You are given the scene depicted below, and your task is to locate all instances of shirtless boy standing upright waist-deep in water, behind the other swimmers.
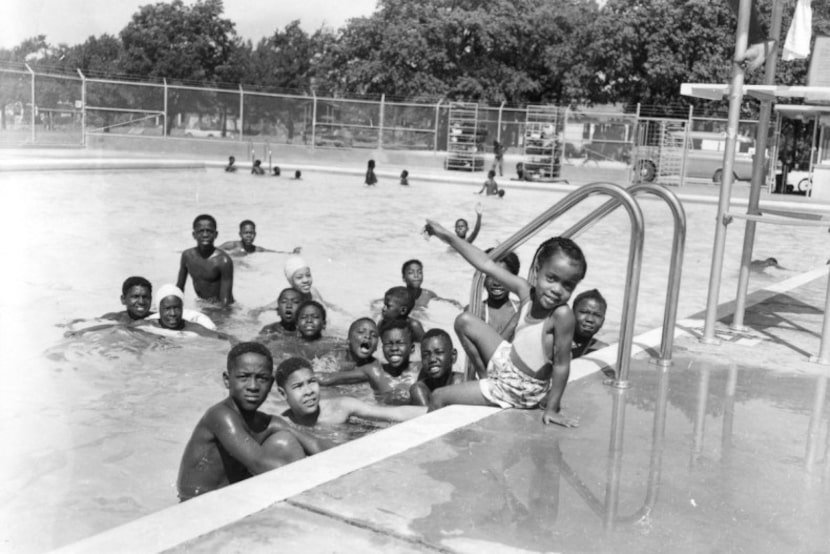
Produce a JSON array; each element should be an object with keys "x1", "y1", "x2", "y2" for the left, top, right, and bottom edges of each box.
[{"x1": 176, "y1": 214, "x2": 233, "y2": 306}]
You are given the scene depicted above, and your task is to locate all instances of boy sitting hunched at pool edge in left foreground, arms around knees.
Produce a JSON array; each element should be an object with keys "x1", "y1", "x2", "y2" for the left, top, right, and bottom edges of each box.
[{"x1": 176, "y1": 342, "x2": 332, "y2": 501}]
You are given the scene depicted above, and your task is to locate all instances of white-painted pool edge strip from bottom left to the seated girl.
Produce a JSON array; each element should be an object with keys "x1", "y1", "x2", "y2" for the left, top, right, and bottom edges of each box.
[{"x1": 54, "y1": 406, "x2": 500, "y2": 553}]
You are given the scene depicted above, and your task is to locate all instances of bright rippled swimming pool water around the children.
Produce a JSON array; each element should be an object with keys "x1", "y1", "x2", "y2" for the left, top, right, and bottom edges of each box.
[{"x1": 0, "y1": 166, "x2": 828, "y2": 551}]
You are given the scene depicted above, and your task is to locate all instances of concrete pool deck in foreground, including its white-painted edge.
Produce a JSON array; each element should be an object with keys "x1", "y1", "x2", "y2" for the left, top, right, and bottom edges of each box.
[{"x1": 50, "y1": 268, "x2": 830, "y2": 553}]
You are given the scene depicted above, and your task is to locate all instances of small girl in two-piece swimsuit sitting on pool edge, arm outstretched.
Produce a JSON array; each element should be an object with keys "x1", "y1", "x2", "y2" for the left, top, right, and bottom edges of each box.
[{"x1": 426, "y1": 220, "x2": 587, "y2": 427}]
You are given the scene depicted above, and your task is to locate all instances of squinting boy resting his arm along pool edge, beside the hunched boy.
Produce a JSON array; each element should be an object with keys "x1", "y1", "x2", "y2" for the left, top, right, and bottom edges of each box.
[{"x1": 277, "y1": 358, "x2": 426, "y2": 427}]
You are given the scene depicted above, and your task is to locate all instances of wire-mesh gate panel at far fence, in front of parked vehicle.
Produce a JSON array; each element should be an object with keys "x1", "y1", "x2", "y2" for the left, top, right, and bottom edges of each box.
[{"x1": 633, "y1": 117, "x2": 689, "y2": 186}]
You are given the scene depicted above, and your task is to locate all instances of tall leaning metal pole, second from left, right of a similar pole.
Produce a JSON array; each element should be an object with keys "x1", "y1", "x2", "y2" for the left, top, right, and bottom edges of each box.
[{"x1": 731, "y1": 0, "x2": 784, "y2": 329}]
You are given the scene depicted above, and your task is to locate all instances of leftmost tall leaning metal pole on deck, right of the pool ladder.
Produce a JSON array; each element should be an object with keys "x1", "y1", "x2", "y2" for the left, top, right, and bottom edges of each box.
[{"x1": 701, "y1": 0, "x2": 750, "y2": 344}]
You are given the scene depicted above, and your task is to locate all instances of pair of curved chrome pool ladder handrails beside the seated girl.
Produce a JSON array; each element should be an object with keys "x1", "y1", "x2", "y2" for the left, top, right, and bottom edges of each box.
[{"x1": 467, "y1": 182, "x2": 686, "y2": 389}]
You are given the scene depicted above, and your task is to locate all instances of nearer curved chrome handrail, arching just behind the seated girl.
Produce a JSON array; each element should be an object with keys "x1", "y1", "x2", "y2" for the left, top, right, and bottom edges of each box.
[{"x1": 467, "y1": 183, "x2": 644, "y2": 388}]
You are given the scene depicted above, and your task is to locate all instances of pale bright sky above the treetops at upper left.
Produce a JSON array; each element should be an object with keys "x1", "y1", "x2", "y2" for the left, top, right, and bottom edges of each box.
[{"x1": 0, "y1": 0, "x2": 377, "y2": 48}]
